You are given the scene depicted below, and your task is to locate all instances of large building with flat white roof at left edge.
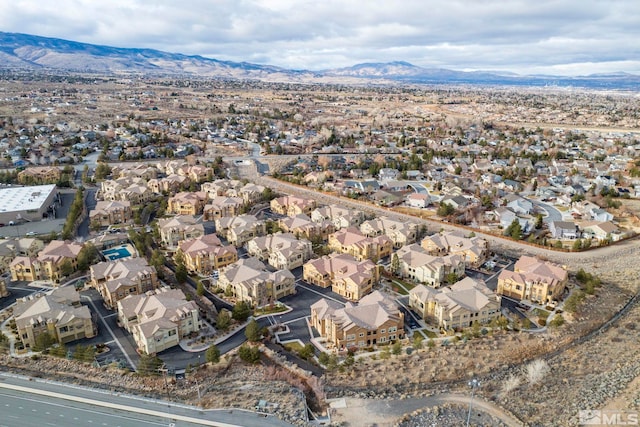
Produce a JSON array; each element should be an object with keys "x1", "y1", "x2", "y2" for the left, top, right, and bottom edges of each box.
[{"x1": 0, "y1": 184, "x2": 58, "y2": 224}]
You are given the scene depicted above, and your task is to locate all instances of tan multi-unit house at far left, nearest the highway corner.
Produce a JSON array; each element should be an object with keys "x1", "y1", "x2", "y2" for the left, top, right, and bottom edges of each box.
[{"x1": 13, "y1": 286, "x2": 97, "y2": 348}]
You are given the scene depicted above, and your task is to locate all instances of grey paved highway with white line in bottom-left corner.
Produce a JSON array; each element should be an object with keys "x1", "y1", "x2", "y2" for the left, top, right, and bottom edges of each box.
[{"x1": 0, "y1": 375, "x2": 290, "y2": 427}]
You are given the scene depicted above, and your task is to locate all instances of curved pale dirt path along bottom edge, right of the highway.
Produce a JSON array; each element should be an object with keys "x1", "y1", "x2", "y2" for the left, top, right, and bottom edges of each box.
[{"x1": 331, "y1": 394, "x2": 523, "y2": 427}]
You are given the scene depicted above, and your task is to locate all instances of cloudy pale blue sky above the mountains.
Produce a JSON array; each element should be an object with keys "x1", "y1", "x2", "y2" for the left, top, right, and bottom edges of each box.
[{"x1": 0, "y1": 0, "x2": 640, "y2": 75}]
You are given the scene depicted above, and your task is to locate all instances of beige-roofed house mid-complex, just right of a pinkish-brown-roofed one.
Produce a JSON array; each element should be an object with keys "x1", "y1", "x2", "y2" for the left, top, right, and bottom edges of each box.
[{"x1": 247, "y1": 233, "x2": 313, "y2": 270}]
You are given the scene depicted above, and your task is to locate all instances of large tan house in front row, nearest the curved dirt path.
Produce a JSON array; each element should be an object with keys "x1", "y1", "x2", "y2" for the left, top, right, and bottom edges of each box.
[{"x1": 311, "y1": 291, "x2": 404, "y2": 350}]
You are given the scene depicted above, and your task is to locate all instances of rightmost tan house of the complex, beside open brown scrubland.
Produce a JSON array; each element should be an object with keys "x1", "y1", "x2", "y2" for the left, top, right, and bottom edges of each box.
[{"x1": 497, "y1": 256, "x2": 569, "y2": 304}]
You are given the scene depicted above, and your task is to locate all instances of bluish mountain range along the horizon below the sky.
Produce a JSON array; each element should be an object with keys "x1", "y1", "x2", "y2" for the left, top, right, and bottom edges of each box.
[{"x1": 0, "y1": 32, "x2": 640, "y2": 90}]
